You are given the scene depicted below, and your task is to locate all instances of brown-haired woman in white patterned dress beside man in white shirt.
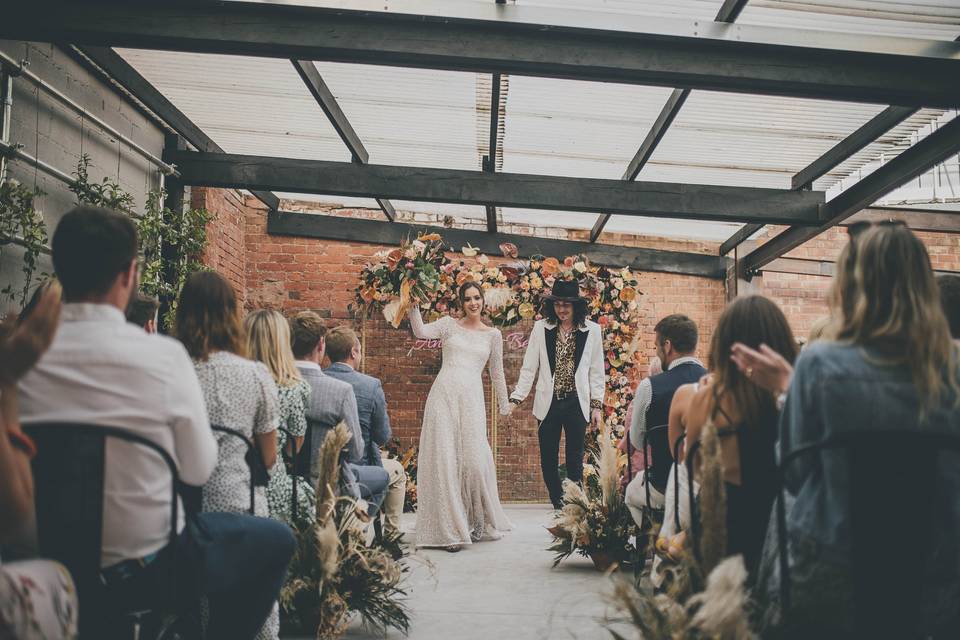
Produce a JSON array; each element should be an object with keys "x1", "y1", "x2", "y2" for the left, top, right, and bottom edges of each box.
[{"x1": 175, "y1": 271, "x2": 280, "y2": 639}]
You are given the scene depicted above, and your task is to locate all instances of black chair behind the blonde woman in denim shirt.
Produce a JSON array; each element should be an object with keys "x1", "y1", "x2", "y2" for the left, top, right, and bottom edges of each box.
[{"x1": 776, "y1": 430, "x2": 960, "y2": 638}]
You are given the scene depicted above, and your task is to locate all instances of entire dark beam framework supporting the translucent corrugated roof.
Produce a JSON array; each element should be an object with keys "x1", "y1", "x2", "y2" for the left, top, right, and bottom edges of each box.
[{"x1": 0, "y1": 0, "x2": 960, "y2": 275}]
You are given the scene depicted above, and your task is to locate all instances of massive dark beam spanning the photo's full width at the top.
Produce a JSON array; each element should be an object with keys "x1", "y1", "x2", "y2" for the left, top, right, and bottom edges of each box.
[{"x1": 7, "y1": 0, "x2": 960, "y2": 108}]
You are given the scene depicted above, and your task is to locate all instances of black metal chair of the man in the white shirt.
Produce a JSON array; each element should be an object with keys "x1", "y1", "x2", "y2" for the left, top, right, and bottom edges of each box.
[{"x1": 24, "y1": 423, "x2": 179, "y2": 640}]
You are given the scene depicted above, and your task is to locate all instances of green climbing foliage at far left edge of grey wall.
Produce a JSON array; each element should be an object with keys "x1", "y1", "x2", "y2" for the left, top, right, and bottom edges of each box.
[{"x1": 0, "y1": 179, "x2": 48, "y2": 307}]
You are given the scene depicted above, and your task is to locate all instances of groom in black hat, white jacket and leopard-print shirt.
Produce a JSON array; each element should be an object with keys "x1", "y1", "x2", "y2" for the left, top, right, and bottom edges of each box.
[{"x1": 510, "y1": 280, "x2": 605, "y2": 509}]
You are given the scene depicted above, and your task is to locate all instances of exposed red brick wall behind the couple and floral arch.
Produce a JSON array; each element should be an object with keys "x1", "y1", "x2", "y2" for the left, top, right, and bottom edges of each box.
[{"x1": 193, "y1": 189, "x2": 960, "y2": 501}]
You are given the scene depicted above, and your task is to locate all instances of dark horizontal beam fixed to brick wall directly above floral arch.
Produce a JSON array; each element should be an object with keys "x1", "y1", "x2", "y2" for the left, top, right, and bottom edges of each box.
[{"x1": 267, "y1": 211, "x2": 730, "y2": 279}]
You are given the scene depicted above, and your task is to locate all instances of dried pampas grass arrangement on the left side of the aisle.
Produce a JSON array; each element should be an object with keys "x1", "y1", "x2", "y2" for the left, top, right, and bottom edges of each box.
[{"x1": 280, "y1": 423, "x2": 410, "y2": 640}]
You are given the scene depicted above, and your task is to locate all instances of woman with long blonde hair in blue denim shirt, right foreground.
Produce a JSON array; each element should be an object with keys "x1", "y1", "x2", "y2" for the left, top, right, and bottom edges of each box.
[{"x1": 758, "y1": 224, "x2": 960, "y2": 638}]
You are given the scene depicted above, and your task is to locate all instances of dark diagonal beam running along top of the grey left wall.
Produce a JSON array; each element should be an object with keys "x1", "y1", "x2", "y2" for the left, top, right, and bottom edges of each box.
[{"x1": 78, "y1": 47, "x2": 280, "y2": 209}]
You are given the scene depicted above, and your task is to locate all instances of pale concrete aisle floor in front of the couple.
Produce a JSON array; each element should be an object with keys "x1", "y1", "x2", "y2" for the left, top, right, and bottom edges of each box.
[{"x1": 345, "y1": 505, "x2": 628, "y2": 640}]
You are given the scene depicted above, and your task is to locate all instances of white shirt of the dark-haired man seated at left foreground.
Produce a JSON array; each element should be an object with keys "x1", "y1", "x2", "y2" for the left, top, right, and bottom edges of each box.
[{"x1": 19, "y1": 304, "x2": 217, "y2": 567}]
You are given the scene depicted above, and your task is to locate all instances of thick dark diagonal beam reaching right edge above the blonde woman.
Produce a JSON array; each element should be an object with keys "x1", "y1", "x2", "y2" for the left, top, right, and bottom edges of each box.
[{"x1": 741, "y1": 118, "x2": 960, "y2": 275}]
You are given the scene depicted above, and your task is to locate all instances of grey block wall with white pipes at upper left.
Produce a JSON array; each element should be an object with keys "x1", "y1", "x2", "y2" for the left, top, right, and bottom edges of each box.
[{"x1": 0, "y1": 40, "x2": 164, "y2": 314}]
